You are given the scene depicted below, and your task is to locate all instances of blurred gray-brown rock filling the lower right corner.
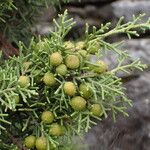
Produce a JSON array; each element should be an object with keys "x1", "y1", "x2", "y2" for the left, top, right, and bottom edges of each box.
[{"x1": 85, "y1": 72, "x2": 150, "y2": 150}]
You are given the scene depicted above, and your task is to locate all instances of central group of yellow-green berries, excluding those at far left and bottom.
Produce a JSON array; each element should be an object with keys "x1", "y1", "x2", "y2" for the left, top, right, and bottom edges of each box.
[{"x1": 43, "y1": 41, "x2": 107, "y2": 116}]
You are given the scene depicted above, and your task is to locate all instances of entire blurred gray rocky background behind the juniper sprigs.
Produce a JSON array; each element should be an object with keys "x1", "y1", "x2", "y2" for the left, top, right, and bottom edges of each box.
[{"x1": 36, "y1": 0, "x2": 150, "y2": 150}]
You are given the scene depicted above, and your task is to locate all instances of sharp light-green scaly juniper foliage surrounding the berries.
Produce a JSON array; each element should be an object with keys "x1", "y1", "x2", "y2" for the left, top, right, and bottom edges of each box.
[{"x1": 0, "y1": 11, "x2": 150, "y2": 150}]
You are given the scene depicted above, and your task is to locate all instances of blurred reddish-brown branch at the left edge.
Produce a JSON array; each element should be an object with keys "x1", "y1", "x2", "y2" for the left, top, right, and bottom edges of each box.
[{"x1": 0, "y1": 33, "x2": 19, "y2": 58}]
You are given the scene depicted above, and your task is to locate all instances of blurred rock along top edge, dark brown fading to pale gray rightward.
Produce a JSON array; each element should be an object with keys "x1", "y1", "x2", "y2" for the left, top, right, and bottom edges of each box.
[{"x1": 65, "y1": 0, "x2": 150, "y2": 35}]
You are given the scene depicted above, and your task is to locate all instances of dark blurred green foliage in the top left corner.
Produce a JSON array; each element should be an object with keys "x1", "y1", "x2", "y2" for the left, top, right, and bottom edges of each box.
[{"x1": 0, "y1": 0, "x2": 74, "y2": 44}]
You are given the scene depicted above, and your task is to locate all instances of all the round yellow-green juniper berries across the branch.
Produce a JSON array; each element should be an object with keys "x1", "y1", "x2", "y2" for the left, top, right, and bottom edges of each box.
[{"x1": 16, "y1": 41, "x2": 108, "y2": 150}]
